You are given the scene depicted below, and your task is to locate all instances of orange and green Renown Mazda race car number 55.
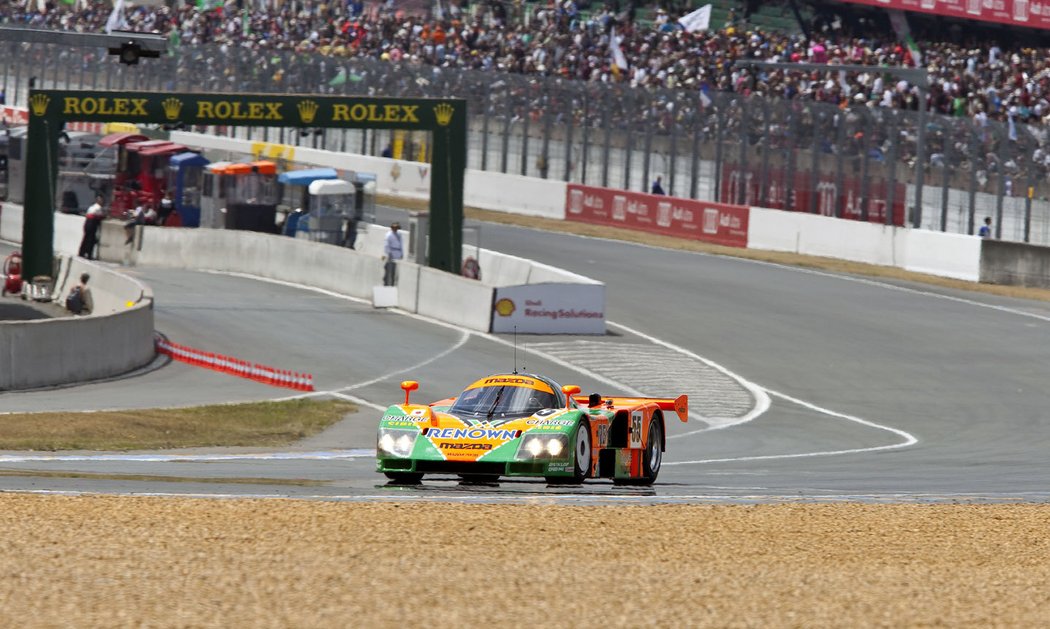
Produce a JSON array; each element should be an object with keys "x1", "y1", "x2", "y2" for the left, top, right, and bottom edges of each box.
[{"x1": 376, "y1": 373, "x2": 689, "y2": 485}]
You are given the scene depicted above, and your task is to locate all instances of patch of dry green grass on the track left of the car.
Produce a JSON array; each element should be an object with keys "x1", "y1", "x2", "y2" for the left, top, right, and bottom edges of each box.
[{"x1": 0, "y1": 399, "x2": 357, "y2": 450}]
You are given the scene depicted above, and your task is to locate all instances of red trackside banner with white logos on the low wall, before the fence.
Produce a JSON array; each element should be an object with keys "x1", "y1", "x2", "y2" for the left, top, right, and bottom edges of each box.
[{"x1": 565, "y1": 184, "x2": 751, "y2": 248}]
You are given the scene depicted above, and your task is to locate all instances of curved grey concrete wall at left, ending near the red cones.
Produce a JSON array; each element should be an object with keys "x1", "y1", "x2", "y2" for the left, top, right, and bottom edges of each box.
[{"x1": 0, "y1": 258, "x2": 153, "y2": 391}]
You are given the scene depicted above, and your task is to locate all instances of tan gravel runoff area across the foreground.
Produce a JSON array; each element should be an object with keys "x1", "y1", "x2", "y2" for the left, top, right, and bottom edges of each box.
[{"x1": 0, "y1": 494, "x2": 1050, "y2": 628}]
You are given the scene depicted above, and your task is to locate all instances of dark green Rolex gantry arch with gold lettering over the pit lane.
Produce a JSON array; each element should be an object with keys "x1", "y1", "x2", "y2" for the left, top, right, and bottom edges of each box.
[{"x1": 22, "y1": 89, "x2": 466, "y2": 277}]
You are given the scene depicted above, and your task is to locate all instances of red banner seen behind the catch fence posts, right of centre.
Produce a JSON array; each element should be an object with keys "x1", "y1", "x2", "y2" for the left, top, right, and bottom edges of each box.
[{"x1": 721, "y1": 164, "x2": 907, "y2": 227}]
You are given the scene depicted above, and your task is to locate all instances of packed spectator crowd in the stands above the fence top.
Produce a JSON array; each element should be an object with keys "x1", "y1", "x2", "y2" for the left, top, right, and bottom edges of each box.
[{"x1": 0, "y1": 0, "x2": 1050, "y2": 124}]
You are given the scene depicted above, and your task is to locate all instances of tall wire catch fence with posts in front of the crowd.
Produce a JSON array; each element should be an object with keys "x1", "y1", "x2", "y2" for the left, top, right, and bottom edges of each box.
[{"x1": 0, "y1": 43, "x2": 1050, "y2": 245}]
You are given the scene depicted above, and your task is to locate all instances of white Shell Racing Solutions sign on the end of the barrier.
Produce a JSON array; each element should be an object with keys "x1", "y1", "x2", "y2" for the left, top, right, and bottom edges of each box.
[{"x1": 491, "y1": 284, "x2": 605, "y2": 334}]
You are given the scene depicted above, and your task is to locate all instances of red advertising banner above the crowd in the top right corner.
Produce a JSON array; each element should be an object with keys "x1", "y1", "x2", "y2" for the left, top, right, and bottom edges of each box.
[{"x1": 843, "y1": 0, "x2": 1050, "y2": 28}]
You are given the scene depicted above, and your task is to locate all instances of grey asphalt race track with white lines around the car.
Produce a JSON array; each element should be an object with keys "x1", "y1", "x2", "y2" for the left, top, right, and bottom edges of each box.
[{"x1": 0, "y1": 210, "x2": 1050, "y2": 502}]
